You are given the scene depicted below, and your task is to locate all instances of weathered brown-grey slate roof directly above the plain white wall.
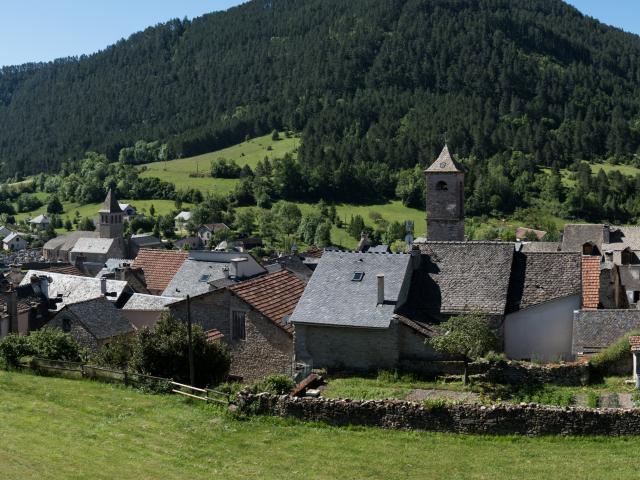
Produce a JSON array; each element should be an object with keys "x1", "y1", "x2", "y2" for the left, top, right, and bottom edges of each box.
[{"x1": 508, "y1": 252, "x2": 584, "y2": 311}]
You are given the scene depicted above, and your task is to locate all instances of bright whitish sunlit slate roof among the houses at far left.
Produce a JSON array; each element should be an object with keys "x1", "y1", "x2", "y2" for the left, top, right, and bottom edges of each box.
[{"x1": 20, "y1": 270, "x2": 127, "y2": 310}]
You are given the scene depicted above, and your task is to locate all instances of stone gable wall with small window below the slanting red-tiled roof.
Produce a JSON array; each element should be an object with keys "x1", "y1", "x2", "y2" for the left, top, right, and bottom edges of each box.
[{"x1": 168, "y1": 289, "x2": 293, "y2": 382}]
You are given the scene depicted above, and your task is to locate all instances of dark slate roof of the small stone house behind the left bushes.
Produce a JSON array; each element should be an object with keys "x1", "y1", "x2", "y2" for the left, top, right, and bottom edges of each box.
[{"x1": 59, "y1": 297, "x2": 135, "y2": 340}]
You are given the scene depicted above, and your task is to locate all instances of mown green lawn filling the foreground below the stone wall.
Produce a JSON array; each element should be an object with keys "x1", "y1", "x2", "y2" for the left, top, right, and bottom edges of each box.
[{"x1": 0, "y1": 371, "x2": 638, "y2": 480}]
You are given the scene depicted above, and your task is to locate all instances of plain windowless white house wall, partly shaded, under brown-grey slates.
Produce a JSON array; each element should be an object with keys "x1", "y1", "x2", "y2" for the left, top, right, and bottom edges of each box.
[{"x1": 504, "y1": 295, "x2": 580, "y2": 361}]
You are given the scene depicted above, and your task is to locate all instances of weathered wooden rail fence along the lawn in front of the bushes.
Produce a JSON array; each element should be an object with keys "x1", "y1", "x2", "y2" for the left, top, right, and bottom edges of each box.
[{"x1": 21, "y1": 357, "x2": 231, "y2": 405}]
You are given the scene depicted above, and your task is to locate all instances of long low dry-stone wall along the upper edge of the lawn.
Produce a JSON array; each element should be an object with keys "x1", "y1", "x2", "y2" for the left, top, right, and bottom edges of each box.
[{"x1": 237, "y1": 393, "x2": 640, "y2": 436}]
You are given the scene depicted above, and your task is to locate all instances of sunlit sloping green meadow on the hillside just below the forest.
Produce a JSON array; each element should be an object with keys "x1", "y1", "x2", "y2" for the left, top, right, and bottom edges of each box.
[{"x1": 141, "y1": 134, "x2": 300, "y2": 194}]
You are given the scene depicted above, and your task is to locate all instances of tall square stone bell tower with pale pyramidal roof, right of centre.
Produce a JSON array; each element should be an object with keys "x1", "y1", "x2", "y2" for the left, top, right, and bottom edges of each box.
[{"x1": 425, "y1": 145, "x2": 464, "y2": 241}]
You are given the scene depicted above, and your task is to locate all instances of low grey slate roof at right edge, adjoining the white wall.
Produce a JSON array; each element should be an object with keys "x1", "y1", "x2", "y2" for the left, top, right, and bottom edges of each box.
[{"x1": 572, "y1": 310, "x2": 640, "y2": 355}]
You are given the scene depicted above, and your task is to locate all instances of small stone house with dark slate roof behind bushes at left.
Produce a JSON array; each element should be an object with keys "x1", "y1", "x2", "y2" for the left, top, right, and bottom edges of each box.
[{"x1": 47, "y1": 297, "x2": 135, "y2": 351}]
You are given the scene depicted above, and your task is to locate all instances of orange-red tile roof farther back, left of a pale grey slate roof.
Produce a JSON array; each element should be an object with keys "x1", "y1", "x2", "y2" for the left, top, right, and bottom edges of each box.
[{"x1": 131, "y1": 248, "x2": 189, "y2": 294}]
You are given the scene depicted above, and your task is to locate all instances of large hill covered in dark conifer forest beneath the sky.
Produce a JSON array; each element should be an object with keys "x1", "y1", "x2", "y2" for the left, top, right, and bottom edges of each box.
[{"x1": 0, "y1": 0, "x2": 640, "y2": 184}]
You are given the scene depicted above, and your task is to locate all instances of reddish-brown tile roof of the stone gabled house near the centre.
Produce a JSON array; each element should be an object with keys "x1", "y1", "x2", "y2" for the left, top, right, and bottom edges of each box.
[{"x1": 229, "y1": 270, "x2": 305, "y2": 332}]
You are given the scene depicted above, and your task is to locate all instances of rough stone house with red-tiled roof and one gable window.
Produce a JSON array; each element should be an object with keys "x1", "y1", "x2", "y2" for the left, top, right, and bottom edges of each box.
[{"x1": 168, "y1": 270, "x2": 304, "y2": 382}]
